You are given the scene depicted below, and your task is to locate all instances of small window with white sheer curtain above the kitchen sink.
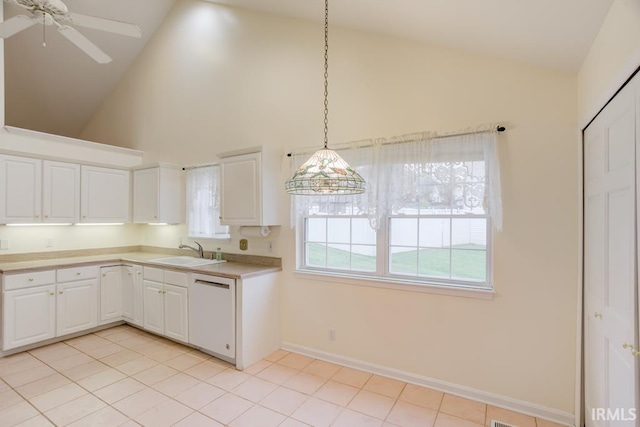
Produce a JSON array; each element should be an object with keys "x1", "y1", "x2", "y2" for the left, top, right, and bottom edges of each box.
[{"x1": 186, "y1": 165, "x2": 229, "y2": 239}]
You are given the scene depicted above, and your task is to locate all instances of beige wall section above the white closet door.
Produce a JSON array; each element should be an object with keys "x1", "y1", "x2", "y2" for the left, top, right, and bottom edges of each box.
[{"x1": 578, "y1": 0, "x2": 640, "y2": 127}]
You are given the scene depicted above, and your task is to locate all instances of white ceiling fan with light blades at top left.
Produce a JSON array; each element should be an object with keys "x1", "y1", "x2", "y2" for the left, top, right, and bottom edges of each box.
[{"x1": 0, "y1": 0, "x2": 142, "y2": 64}]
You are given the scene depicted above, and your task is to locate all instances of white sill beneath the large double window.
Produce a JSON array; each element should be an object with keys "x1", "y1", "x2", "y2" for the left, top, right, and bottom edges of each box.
[{"x1": 295, "y1": 270, "x2": 495, "y2": 300}]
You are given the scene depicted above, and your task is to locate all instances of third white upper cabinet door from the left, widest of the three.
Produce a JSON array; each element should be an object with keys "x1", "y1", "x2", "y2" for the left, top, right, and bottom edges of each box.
[{"x1": 80, "y1": 166, "x2": 130, "y2": 223}]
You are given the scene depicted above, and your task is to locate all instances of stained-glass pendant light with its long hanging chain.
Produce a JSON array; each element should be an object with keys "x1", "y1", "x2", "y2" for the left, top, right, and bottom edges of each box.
[{"x1": 285, "y1": 0, "x2": 366, "y2": 196}]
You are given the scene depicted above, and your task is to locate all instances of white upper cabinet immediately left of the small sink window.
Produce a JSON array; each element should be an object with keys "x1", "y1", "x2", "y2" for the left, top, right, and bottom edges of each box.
[{"x1": 133, "y1": 165, "x2": 184, "y2": 224}]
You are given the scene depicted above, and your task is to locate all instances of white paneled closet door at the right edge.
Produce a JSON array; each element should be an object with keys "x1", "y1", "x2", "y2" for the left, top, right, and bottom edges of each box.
[{"x1": 584, "y1": 72, "x2": 640, "y2": 427}]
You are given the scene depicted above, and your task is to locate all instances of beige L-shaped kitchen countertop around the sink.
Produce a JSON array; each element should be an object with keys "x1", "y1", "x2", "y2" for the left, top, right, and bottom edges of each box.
[{"x1": 0, "y1": 252, "x2": 282, "y2": 279}]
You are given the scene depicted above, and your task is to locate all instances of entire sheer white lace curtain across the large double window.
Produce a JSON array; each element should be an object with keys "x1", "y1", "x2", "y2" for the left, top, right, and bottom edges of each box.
[{"x1": 292, "y1": 131, "x2": 502, "y2": 230}]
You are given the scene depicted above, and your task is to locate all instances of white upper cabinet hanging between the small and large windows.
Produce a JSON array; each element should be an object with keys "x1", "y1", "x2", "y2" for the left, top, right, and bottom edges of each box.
[{"x1": 218, "y1": 147, "x2": 284, "y2": 226}]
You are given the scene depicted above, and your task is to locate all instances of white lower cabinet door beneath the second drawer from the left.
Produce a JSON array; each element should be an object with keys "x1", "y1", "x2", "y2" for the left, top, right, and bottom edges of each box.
[{"x1": 56, "y1": 279, "x2": 98, "y2": 336}]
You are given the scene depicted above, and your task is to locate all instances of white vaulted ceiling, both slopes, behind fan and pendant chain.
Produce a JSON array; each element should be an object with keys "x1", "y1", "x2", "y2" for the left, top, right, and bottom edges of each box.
[{"x1": 4, "y1": 0, "x2": 613, "y2": 136}]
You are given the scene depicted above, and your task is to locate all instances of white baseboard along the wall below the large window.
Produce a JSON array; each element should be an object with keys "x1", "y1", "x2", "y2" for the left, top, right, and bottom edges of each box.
[{"x1": 282, "y1": 343, "x2": 575, "y2": 426}]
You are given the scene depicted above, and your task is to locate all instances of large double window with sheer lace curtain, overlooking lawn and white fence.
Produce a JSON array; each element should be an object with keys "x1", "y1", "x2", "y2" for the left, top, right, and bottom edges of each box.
[{"x1": 294, "y1": 134, "x2": 501, "y2": 289}]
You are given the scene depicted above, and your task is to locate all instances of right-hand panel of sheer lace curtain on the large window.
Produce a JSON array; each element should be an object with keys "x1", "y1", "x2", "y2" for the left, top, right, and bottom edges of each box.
[{"x1": 378, "y1": 132, "x2": 502, "y2": 230}]
